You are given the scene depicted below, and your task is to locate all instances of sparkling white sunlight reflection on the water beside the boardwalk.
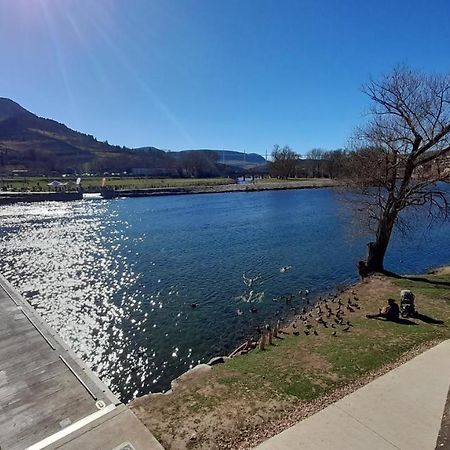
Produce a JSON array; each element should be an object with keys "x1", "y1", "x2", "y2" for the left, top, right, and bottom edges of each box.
[{"x1": 0, "y1": 202, "x2": 144, "y2": 400}]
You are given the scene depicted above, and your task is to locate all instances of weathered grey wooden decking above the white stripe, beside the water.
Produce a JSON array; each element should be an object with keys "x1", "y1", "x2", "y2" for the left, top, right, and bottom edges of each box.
[{"x1": 0, "y1": 276, "x2": 117, "y2": 450}]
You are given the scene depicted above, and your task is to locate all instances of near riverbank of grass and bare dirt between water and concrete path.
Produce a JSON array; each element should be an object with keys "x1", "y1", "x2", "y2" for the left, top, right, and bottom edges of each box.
[{"x1": 131, "y1": 268, "x2": 450, "y2": 449}]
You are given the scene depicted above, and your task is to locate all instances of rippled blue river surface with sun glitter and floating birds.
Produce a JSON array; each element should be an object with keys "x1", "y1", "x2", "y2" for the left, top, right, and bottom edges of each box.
[{"x1": 0, "y1": 189, "x2": 450, "y2": 401}]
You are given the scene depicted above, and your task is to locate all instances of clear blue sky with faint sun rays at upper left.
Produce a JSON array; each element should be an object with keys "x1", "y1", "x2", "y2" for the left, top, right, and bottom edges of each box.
[{"x1": 0, "y1": 0, "x2": 450, "y2": 154}]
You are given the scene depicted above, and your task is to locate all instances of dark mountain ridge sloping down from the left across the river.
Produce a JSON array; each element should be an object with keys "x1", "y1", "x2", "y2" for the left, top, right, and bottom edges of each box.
[{"x1": 0, "y1": 97, "x2": 265, "y2": 176}]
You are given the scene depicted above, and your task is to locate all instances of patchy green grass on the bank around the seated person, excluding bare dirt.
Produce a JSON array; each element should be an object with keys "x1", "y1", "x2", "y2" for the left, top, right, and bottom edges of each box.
[{"x1": 212, "y1": 268, "x2": 450, "y2": 400}]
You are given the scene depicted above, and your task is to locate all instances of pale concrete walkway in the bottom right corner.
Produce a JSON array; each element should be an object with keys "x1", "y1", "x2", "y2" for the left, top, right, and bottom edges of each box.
[{"x1": 257, "y1": 340, "x2": 450, "y2": 450}]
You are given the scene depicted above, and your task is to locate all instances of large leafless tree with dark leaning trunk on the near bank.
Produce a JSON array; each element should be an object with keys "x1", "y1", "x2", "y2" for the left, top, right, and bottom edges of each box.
[{"x1": 347, "y1": 67, "x2": 450, "y2": 276}]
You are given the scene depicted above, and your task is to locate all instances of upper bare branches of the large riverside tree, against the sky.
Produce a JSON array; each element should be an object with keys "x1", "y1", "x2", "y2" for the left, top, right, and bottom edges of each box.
[{"x1": 363, "y1": 67, "x2": 450, "y2": 159}]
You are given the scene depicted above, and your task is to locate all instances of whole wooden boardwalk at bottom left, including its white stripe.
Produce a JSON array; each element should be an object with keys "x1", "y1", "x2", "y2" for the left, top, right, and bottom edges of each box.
[{"x1": 0, "y1": 276, "x2": 162, "y2": 450}]
